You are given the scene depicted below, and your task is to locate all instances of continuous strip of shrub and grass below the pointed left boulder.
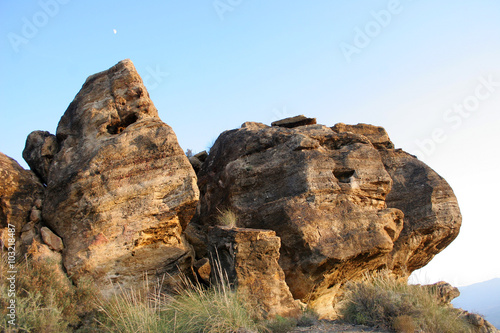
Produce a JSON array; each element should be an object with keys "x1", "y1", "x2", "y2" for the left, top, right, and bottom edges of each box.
[{"x1": 0, "y1": 245, "x2": 317, "y2": 333}]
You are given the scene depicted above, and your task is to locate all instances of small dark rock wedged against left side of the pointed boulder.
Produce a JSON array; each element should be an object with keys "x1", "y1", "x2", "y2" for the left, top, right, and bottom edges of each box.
[{"x1": 23, "y1": 131, "x2": 59, "y2": 184}]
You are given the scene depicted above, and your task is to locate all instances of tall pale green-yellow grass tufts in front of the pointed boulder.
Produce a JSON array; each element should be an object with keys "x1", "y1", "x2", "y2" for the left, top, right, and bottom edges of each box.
[{"x1": 101, "y1": 260, "x2": 259, "y2": 333}]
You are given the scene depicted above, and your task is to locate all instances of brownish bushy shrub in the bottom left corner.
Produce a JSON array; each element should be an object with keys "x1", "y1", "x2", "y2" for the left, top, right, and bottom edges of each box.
[{"x1": 0, "y1": 248, "x2": 96, "y2": 333}]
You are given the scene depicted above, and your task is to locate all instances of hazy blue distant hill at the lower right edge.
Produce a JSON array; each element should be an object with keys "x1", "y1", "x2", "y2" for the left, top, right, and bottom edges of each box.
[{"x1": 452, "y1": 278, "x2": 500, "y2": 328}]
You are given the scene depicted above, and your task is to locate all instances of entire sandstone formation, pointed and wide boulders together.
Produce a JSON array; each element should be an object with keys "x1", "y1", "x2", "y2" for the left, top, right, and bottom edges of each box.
[{"x1": 14, "y1": 60, "x2": 461, "y2": 318}]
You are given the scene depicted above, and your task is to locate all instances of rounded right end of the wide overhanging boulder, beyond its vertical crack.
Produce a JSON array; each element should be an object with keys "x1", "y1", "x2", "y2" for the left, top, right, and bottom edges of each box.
[{"x1": 380, "y1": 149, "x2": 462, "y2": 272}]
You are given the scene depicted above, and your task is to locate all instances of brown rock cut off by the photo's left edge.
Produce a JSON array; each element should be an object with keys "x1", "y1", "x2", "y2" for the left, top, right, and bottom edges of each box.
[{"x1": 0, "y1": 153, "x2": 43, "y2": 237}]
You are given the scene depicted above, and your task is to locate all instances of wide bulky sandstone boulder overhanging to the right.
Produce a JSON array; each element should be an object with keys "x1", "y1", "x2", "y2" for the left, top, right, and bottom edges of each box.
[{"x1": 195, "y1": 118, "x2": 461, "y2": 318}]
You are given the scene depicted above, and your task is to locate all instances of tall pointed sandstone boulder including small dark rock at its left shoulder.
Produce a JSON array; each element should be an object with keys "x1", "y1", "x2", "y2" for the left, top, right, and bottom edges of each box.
[{"x1": 25, "y1": 60, "x2": 198, "y2": 295}]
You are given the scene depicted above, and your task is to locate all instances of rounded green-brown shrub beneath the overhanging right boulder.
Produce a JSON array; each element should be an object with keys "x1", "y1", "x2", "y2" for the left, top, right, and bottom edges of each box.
[{"x1": 341, "y1": 272, "x2": 474, "y2": 333}]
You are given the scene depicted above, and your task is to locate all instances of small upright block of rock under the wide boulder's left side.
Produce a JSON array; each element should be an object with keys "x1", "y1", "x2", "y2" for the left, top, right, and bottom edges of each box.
[{"x1": 208, "y1": 227, "x2": 300, "y2": 319}]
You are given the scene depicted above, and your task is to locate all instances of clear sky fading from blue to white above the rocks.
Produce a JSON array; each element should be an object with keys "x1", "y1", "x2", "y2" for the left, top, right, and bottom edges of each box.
[{"x1": 0, "y1": 0, "x2": 500, "y2": 286}]
